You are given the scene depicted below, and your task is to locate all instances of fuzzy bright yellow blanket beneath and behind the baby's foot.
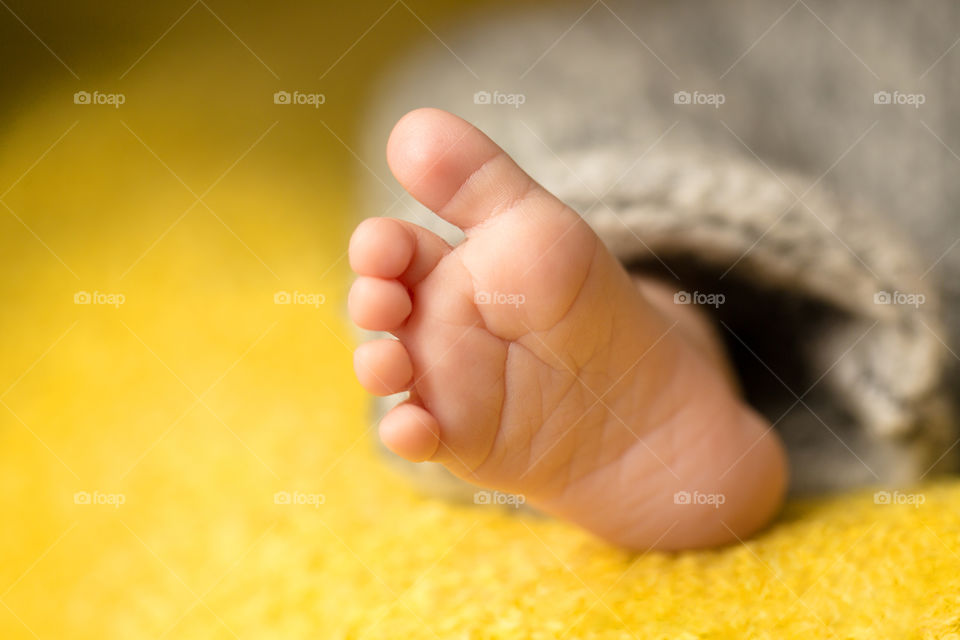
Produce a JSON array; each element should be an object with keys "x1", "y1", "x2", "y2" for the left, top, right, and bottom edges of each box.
[{"x1": 0, "y1": 0, "x2": 960, "y2": 639}]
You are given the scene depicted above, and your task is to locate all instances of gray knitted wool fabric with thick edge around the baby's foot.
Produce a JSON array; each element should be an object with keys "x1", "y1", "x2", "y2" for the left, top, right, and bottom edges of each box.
[{"x1": 363, "y1": 0, "x2": 960, "y2": 492}]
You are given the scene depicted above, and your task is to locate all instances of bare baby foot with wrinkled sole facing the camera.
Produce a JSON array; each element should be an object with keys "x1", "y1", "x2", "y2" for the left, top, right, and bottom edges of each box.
[{"x1": 349, "y1": 109, "x2": 785, "y2": 549}]
